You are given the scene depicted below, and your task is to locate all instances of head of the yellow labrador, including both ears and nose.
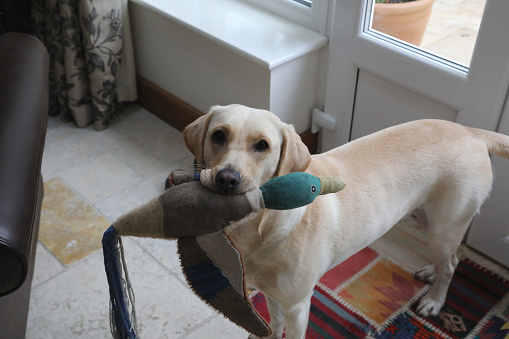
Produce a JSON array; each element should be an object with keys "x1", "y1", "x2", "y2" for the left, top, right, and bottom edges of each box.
[{"x1": 183, "y1": 105, "x2": 311, "y2": 194}]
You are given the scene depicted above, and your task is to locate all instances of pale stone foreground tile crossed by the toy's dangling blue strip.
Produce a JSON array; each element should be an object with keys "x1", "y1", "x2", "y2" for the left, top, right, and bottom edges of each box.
[{"x1": 27, "y1": 238, "x2": 216, "y2": 339}]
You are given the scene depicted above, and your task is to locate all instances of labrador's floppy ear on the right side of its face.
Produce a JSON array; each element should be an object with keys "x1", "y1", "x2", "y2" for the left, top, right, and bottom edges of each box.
[{"x1": 276, "y1": 124, "x2": 311, "y2": 176}]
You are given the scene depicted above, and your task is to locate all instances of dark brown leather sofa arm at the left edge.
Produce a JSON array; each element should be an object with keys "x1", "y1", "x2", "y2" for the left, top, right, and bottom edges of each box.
[{"x1": 0, "y1": 33, "x2": 49, "y2": 297}]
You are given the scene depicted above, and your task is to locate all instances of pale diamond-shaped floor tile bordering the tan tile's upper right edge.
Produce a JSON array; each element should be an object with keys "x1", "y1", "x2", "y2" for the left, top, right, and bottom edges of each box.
[{"x1": 60, "y1": 154, "x2": 141, "y2": 204}]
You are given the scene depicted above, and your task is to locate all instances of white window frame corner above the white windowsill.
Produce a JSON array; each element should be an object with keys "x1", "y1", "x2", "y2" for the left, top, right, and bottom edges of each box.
[{"x1": 243, "y1": 0, "x2": 333, "y2": 35}]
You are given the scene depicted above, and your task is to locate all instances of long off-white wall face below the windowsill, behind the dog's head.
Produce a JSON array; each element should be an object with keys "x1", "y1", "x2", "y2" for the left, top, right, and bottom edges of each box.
[{"x1": 129, "y1": 2, "x2": 270, "y2": 112}]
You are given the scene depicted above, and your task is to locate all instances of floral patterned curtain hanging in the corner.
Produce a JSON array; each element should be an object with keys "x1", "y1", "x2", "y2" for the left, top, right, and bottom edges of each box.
[{"x1": 31, "y1": 0, "x2": 137, "y2": 130}]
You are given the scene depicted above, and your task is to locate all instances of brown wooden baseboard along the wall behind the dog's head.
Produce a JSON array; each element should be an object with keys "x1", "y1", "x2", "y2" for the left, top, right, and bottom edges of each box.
[{"x1": 136, "y1": 75, "x2": 318, "y2": 154}]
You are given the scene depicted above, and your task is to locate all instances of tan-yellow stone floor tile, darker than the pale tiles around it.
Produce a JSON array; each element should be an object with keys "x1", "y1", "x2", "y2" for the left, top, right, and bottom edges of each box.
[{"x1": 39, "y1": 178, "x2": 110, "y2": 265}]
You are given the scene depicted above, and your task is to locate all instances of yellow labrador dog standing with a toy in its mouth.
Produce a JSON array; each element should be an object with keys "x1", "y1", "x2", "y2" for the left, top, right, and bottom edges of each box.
[{"x1": 184, "y1": 105, "x2": 509, "y2": 339}]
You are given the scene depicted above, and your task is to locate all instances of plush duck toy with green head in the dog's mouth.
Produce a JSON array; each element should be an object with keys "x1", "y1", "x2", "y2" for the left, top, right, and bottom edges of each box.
[{"x1": 103, "y1": 170, "x2": 345, "y2": 339}]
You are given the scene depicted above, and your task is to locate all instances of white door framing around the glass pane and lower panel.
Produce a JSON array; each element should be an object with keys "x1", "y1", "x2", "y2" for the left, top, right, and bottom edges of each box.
[{"x1": 321, "y1": 0, "x2": 509, "y2": 151}]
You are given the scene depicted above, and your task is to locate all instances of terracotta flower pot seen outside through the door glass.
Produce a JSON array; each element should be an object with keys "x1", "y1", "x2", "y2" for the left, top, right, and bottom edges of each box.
[{"x1": 372, "y1": 0, "x2": 435, "y2": 46}]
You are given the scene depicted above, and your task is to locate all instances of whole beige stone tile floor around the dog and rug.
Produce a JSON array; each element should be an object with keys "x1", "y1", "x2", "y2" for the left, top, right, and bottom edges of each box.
[{"x1": 26, "y1": 106, "x2": 509, "y2": 339}]
